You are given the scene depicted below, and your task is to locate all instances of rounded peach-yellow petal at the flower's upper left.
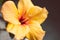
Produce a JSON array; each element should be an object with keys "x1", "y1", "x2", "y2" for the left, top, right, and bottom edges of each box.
[{"x1": 1, "y1": 1, "x2": 20, "y2": 24}]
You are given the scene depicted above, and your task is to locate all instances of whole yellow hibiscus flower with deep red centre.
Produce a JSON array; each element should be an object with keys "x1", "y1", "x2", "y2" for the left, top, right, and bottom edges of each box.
[{"x1": 1, "y1": 0, "x2": 48, "y2": 40}]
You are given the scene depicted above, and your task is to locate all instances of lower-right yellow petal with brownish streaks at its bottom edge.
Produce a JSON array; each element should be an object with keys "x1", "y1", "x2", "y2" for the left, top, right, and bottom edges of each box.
[{"x1": 26, "y1": 21, "x2": 45, "y2": 40}]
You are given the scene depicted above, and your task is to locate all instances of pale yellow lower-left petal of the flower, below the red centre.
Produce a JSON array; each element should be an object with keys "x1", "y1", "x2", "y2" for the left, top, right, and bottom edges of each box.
[{"x1": 7, "y1": 23, "x2": 29, "y2": 39}]
